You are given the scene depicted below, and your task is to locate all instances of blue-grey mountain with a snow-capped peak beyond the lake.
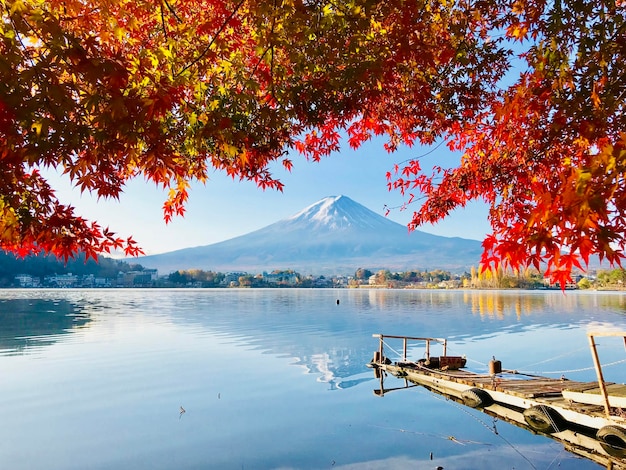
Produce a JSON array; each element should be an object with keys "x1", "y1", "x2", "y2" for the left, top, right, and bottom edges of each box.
[{"x1": 135, "y1": 196, "x2": 481, "y2": 275}]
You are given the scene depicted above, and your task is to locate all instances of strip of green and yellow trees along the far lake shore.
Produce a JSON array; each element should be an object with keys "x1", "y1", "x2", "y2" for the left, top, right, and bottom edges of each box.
[{"x1": 0, "y1": 253, "x2": 626, "y2": 289}]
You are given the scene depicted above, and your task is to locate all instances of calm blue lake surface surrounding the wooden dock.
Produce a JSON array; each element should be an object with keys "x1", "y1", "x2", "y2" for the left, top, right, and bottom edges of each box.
[{"x1": 0, "y1": 289, "x2": 626, "y2": 470}]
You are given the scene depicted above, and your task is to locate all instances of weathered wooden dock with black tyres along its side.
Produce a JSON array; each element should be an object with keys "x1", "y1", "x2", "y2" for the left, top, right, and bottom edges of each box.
[{"x1": 367, "y1": 332, "x2": 626, "y2": 462}]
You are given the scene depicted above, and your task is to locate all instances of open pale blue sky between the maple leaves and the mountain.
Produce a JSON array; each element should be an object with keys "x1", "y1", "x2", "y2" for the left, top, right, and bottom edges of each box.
[{"x1": 46, "y1": 140, "x2": 490, "y2": 254}]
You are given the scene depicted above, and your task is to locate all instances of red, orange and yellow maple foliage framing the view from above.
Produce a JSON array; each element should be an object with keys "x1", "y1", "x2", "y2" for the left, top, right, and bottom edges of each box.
[{"x1": 0, "y1": 0, "x2": 626, "y2": 281}]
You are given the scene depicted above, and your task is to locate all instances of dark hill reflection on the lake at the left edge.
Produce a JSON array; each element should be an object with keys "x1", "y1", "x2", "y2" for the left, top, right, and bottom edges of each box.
[{"x1": 0, "y1": 299, "x2": 91, "y2": 355}]
